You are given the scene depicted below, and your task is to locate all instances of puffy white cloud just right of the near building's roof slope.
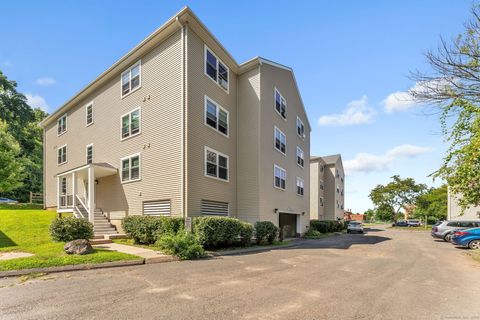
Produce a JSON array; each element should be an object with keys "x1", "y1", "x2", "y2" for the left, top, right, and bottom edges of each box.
[{"x1": 318, "y1": 96, "x2": 376, "y2": 126}]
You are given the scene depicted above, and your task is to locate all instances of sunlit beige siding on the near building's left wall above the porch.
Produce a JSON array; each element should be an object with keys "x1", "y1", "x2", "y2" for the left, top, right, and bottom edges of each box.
[{"x1": 45, "y1": 31, "x2": 182, "y2": 215}]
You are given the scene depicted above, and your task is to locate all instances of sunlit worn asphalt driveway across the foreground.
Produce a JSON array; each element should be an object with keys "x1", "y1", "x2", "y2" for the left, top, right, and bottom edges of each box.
[{"x1": 0, "y1": 228, "x2": 480, "y2": 320}]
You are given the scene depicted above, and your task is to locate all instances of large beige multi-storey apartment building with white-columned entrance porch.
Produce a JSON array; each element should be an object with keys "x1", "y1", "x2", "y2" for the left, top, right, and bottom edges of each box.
[{"x1": 42, "y1": 8, "x2": 310, "y2": 238}]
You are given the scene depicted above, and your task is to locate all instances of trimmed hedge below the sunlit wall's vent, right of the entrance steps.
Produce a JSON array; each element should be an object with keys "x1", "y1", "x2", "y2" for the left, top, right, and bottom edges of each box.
[{"x1": 122, "y1": 216, "x2": 185, "y2": 244}]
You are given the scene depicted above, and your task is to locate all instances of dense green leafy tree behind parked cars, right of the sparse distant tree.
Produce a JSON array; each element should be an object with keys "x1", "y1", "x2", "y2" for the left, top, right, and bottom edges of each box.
[{"x1": 414, "y1": 185, "x2": 448, "y2": 220}]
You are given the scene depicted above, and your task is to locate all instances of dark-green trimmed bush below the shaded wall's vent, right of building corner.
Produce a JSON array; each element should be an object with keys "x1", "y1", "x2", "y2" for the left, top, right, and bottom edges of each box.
[{"x1": 193, "y1": 217, "x2": 243, "y2": 249}]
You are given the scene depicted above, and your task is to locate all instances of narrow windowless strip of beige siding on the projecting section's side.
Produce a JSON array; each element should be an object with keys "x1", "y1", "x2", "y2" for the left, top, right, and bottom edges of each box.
[{"x1": 237, "y1": 67, "x2": 260, "y2": 223}]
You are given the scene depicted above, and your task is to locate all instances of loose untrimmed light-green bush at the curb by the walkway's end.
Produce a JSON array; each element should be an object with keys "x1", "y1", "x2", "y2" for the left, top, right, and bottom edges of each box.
[{"x1": 156, "y1": 230, "x2": 205, "y2": 260}]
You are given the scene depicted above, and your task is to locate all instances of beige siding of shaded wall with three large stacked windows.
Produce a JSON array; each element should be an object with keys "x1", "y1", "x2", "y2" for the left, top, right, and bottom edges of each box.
[{"x1": 187, "y1": 29, "x2": 237, "y2": 216}]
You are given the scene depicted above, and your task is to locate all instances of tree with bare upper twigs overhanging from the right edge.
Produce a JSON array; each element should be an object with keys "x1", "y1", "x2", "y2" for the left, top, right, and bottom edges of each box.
[{"x1": 410, "y1": 4, "x2": 480, "y2": 210}]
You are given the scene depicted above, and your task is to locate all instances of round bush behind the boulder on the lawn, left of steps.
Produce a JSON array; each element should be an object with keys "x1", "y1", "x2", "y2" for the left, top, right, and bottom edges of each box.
[{"x1": 50, "y1": 217, "x2": 93, "y2": 242}]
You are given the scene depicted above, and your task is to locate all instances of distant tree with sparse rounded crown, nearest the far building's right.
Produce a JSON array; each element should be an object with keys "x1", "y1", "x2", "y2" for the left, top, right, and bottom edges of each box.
[{"x1": 369, "y1": 175, "x2": 427, "y2": 221}]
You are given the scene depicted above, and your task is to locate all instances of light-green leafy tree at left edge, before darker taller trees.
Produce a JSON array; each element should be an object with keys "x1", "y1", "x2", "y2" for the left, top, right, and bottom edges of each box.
[{"x1": 0, "y1": 121, "x2": 25, "y2": 193}]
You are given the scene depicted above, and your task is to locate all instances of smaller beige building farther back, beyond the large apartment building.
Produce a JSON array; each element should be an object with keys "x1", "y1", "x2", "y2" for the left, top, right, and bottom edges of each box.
[{"x1": 310, "y1": 154, "x2": 345, "y2": 220}]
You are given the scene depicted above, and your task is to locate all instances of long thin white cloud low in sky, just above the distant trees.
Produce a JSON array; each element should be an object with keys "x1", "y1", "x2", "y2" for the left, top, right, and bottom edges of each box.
[{"x1": 344, "y1": 144, "x2": 431, "y2": 175}]
